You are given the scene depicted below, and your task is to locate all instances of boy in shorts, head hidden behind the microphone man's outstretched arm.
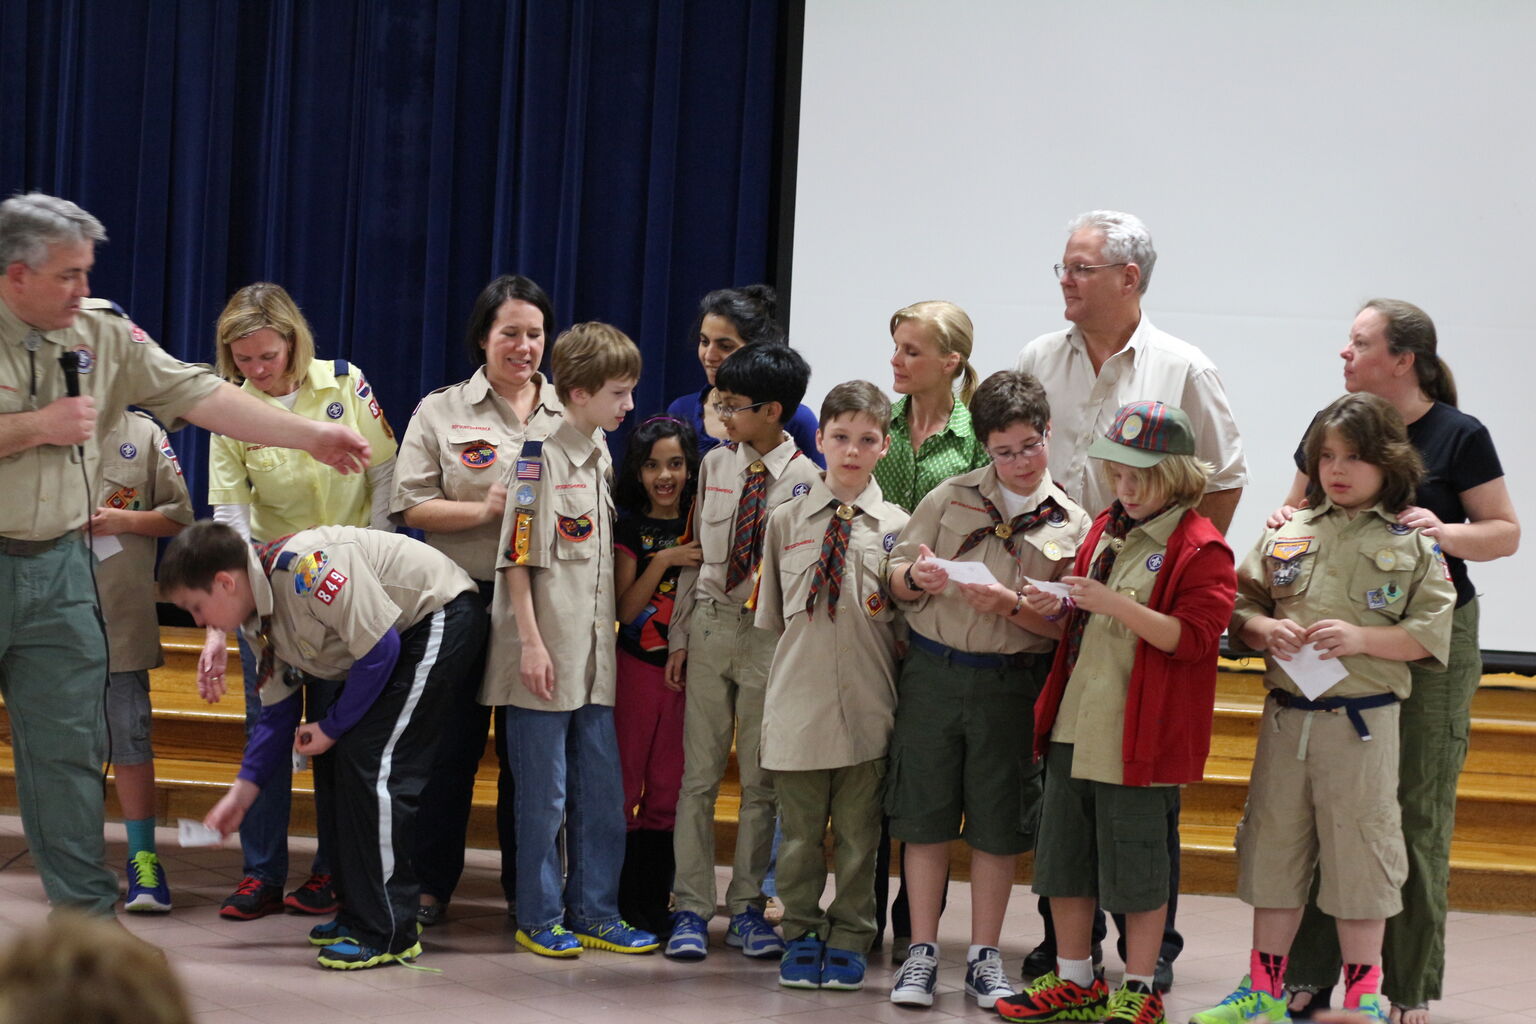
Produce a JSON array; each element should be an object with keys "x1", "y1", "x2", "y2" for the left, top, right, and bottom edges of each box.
[{"x1": 91, "y1": 410, "x2": 192, "y2": 913}]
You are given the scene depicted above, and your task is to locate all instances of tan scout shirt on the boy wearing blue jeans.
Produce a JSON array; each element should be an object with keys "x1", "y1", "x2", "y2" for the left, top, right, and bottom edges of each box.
[{"x1": 479, "y1": 419, "x2": 617, "y2": 711}]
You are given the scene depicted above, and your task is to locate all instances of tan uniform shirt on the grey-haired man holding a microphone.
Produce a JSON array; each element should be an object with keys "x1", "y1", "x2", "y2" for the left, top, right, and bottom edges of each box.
[{"x1": 0, "y1": 301, "x2": 220, "y2": 540}]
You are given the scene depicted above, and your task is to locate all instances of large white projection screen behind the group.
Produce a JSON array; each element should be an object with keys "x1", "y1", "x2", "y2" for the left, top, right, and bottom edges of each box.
[{"x1": 790, "y1": 0, "x2": 1536, "y2": 652}]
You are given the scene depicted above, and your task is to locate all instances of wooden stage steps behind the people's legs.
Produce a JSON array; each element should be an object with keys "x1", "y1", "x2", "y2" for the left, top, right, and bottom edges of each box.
[{"x1": 0, "y1": 628, "x2": 1536, "y2": 912}]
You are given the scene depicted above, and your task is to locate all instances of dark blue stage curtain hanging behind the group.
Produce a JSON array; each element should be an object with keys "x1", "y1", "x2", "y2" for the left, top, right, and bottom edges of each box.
[{"x1": 0, "y1": 0, "x2": 780, "y2": 505}]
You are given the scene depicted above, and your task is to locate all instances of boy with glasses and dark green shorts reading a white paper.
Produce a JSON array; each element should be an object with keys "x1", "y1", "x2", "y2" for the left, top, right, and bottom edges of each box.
[{"x1": 886, "y1": 372, "x2": 1089, "y2": 1009}]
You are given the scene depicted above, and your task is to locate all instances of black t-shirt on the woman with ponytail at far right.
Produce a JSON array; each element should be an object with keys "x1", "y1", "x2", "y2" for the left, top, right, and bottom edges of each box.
[{"x1": 1296, "y1": 402, "x2": 1504, "y2": 608}]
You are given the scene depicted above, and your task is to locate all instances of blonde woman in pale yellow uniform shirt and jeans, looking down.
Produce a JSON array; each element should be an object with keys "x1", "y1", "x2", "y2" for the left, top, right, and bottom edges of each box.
[{"x1": 198, "y1": 281, "x2": 396, "y2": 921}]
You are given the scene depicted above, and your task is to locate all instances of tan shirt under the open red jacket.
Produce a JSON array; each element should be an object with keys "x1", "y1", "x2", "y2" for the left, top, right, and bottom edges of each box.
[{"x1": 1051, "y1": 505, "x2": 1189, "y2": 786}]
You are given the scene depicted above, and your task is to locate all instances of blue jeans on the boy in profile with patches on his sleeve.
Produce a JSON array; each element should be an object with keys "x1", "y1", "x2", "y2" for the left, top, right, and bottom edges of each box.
[{"x1": 507, "y1": 705, "x2": 624, "y2": 935}]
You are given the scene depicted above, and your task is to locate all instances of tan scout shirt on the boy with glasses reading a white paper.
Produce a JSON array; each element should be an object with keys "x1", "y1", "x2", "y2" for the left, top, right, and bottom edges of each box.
[{"x1": 891, "y1": 465, "x2": 1091, "y2": 654}]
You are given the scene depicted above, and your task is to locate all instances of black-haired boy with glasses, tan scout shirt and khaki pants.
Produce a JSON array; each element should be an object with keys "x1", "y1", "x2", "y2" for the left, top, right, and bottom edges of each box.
[{"x1": 667, "y1": 344, "x2": 820, "y2": 960}]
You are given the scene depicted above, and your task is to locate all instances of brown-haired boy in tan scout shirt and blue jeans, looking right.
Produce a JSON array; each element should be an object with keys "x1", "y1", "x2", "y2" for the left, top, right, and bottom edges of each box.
[{"x1": 481, "y1": 324, "x2": 657, "y2": 956}]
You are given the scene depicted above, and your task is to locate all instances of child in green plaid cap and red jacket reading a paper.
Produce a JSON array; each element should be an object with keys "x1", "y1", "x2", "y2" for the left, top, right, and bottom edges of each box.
[{"x1": 997, "y1": 401, "x2": 1236, "y2": 1024}]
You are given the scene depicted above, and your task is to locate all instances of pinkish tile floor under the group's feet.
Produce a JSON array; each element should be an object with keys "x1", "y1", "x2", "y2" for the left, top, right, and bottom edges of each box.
[{"x1": 0, "y1": 815, "x2": 1536, "y2": 1024}]
